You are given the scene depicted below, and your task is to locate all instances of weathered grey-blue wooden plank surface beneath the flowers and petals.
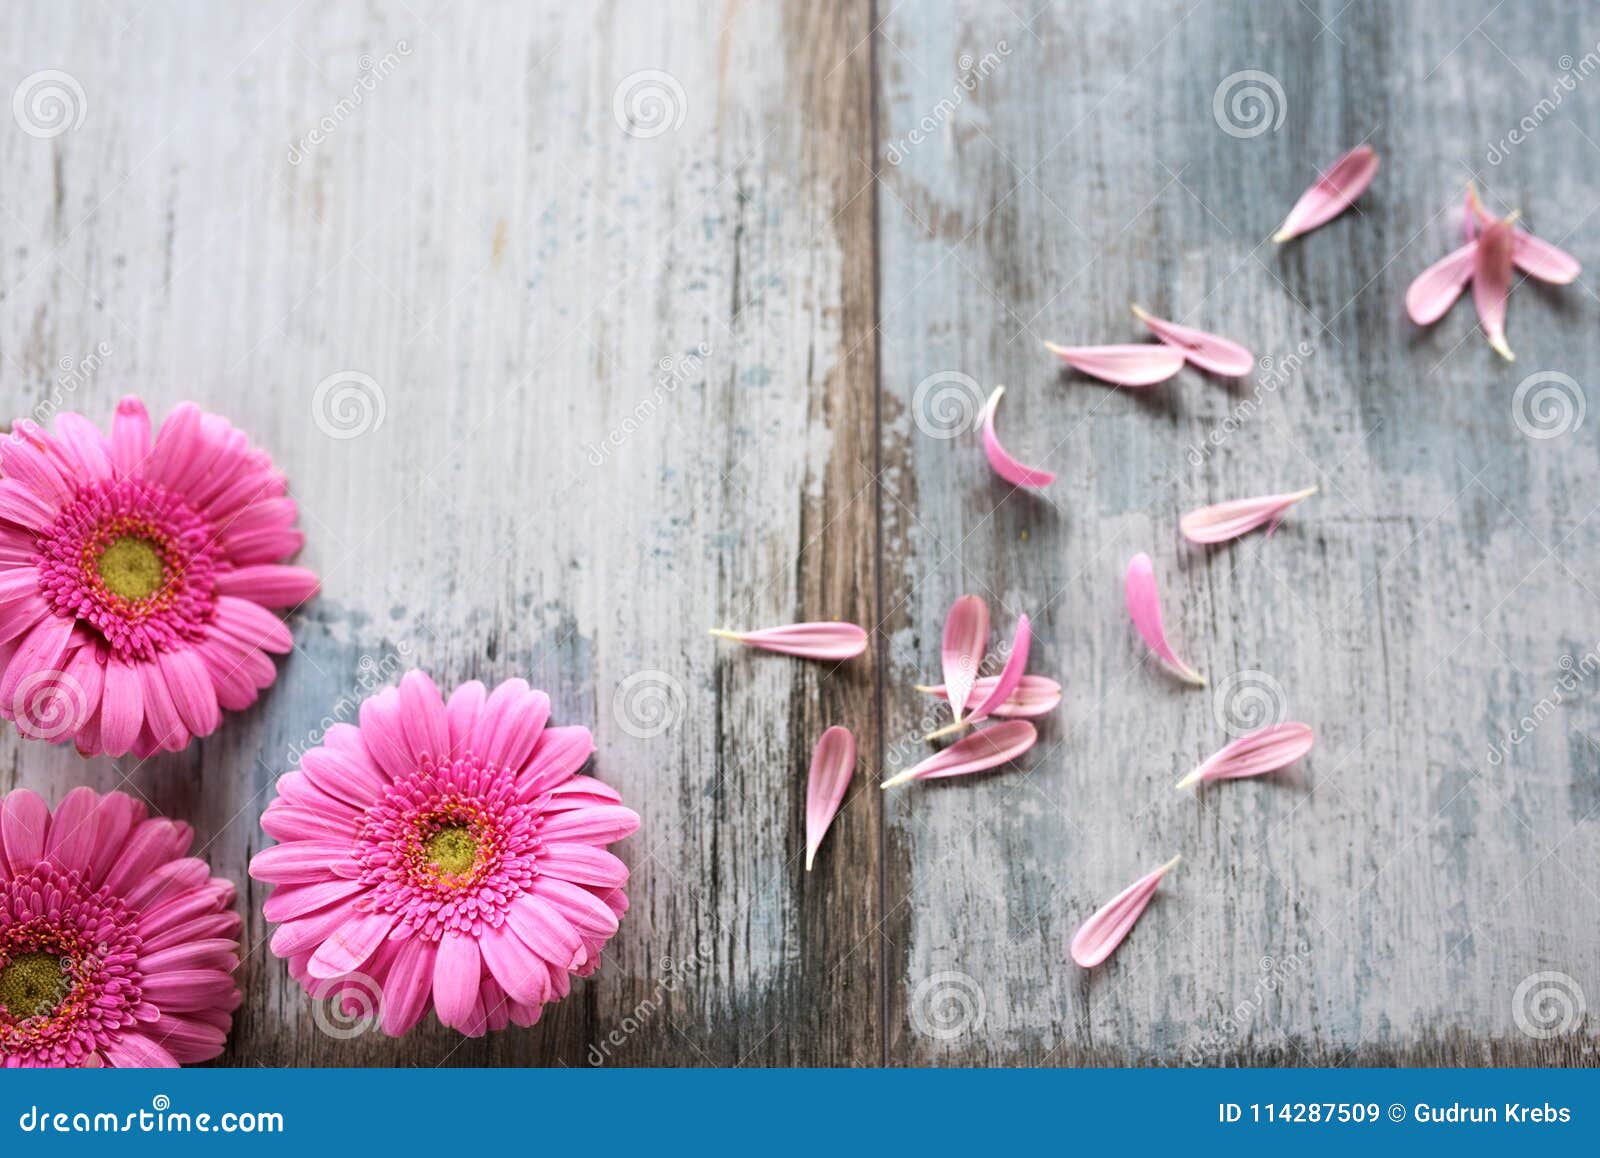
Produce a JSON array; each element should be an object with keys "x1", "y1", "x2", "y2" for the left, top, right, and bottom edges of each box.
[{"x1": 0, "y1": 0, "x2": 1600, "y2": 1065}]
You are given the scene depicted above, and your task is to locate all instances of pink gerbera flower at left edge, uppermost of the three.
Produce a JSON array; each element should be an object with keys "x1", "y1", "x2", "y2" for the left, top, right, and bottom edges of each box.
[{"x1": 0, "y1": 397, "x2": 317, "y2": 757}]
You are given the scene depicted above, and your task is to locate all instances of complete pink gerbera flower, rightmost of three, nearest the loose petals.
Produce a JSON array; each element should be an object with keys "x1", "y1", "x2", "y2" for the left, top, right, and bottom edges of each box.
[{"x1": 250, "y1": 672, "x2": 638, "y2": 1036}]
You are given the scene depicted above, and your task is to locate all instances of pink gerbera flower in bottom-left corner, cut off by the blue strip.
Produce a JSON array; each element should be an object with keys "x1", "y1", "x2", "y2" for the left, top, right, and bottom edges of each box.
[{"x1": 0, "y1": 789, "x2": 240, "y2": 1068}]
